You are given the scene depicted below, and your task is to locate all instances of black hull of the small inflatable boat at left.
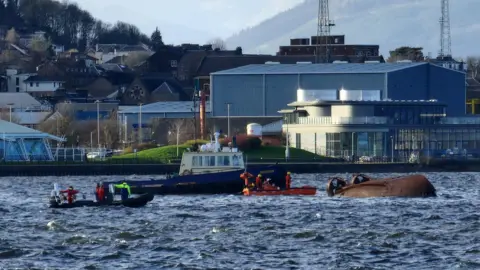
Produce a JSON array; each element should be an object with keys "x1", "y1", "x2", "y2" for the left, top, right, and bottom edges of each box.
[{"x1": 50, "y1": 193, "x2": 155, "y2": 208}]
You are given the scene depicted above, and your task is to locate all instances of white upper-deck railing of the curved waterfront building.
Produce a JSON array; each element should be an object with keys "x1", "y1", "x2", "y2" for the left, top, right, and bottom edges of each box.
[{"x1": 297, "y1": 116, "x2": 388, "y2": 125}]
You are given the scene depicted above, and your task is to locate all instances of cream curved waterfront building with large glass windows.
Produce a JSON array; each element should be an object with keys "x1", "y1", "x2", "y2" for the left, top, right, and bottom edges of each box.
[{"x1": 280, "y1": 89, "x2": 480, "y2": 161}]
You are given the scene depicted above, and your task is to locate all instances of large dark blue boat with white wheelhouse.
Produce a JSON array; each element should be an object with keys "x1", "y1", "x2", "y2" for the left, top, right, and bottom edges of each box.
[{"x1": 104, "y1": 132, "x2": 286, "y2": 195}]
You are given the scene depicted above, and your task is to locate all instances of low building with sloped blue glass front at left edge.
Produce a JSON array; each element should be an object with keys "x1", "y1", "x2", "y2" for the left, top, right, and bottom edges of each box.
[{"x1": 0, "y1": 120, "x2": 65, "y2": 162}]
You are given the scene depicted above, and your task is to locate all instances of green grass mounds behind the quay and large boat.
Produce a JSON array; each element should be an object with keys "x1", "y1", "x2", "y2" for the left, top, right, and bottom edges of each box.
[{"x1": 113, "y1": 144, "x2": 327, "y2": 162}]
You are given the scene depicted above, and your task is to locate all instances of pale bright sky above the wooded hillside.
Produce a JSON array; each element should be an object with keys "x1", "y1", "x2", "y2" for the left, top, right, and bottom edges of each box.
[{"x1": 72, "y1": 0, "x2": 303, "y2": 44}]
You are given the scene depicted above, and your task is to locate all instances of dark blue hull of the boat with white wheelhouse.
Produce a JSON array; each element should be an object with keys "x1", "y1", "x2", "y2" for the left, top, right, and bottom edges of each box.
[{"x1": 104, "y1": 163, "x2": 286, "y2": 195}]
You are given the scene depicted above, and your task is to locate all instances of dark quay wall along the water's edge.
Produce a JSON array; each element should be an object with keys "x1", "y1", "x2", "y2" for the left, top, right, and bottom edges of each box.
[{"x1": 0, "y1": 160, "x2": 480, "y2": 177}]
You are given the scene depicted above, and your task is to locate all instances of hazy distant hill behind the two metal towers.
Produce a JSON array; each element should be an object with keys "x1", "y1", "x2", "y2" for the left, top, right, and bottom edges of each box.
[{"x1": 226, "y1": 0, "x2": 480, "y2": 57}]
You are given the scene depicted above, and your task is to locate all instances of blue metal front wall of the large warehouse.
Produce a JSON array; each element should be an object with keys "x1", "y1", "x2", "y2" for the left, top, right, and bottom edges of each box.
[{"x1": 211, "y1": 74, "x2": 385, "y2": 117}]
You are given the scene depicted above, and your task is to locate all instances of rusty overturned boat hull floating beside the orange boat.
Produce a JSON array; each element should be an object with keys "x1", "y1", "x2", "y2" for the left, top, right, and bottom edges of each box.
[{"x1": 327, "y1": 174, "x2": 436, "y2": 198}]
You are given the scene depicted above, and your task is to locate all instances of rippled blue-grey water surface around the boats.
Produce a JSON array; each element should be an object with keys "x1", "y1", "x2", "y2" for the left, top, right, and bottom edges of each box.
[{"x1": 0, "y1": 173, "x2": 480, "y2": 269}]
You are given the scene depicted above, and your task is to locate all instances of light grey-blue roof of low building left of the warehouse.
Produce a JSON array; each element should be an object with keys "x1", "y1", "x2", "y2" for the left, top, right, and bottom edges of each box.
[{"x1": 119, "y1": 101, "x2": 210, "y2": 113}]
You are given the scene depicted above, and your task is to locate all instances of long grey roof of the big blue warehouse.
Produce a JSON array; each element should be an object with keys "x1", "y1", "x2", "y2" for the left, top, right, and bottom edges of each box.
[{"x1": 212, "y1": 62, "x2": 428, "y2": 75}]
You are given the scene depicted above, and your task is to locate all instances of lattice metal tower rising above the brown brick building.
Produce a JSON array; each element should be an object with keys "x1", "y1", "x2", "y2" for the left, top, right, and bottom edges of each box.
[{"x1": 315, "y1": 0, "x2": 335, "y2": 63}]
